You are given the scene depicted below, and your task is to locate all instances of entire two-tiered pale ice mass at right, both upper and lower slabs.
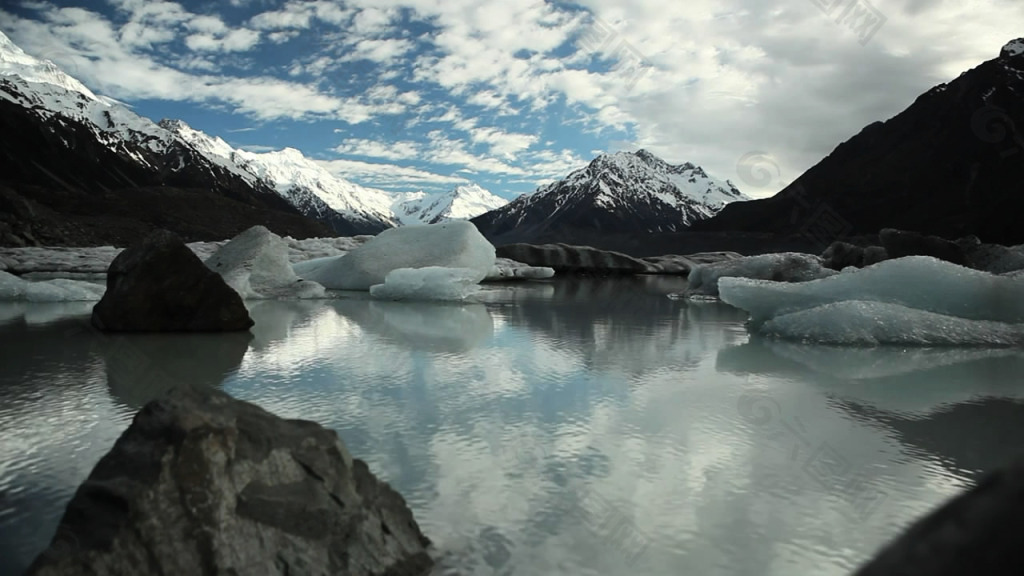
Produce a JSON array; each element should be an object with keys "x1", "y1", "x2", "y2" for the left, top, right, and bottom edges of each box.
[{"x1": 719, "y1": 256, "x2": 1024, "y2": 346}]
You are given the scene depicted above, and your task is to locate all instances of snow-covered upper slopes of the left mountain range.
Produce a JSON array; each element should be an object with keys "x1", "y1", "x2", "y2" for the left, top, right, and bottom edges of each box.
[{"x1": 0, "y1": 33, "x2": 397, "y2": 240}]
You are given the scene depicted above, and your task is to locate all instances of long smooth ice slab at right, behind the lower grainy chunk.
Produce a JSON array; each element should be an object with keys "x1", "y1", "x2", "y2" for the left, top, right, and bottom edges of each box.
[{"x1": 719, "y1": 256, "x2": 1024, "y2": 327}]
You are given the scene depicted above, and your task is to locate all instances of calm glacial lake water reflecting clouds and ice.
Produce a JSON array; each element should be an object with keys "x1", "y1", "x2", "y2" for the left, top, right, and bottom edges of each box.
[{"x1": 0, "y1": 277, "x2": 1024, "y2": 576}]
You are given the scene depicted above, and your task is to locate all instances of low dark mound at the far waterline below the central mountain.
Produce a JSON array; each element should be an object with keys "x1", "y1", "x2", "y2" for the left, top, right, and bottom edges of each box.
[{"x1": 496, "y1": 244, "x2": 656, "y2": 275}]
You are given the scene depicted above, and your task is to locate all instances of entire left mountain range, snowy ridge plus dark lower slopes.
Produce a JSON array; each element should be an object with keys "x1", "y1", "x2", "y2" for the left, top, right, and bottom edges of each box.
[{"x1": 0, "y1": 33, "x2": 506, "y2": 245}]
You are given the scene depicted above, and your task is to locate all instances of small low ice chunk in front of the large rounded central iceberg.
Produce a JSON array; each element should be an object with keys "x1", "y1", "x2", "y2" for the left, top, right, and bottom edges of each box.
[{"x1": 370, "y1": 266, "x2": 479, "y2": 300}]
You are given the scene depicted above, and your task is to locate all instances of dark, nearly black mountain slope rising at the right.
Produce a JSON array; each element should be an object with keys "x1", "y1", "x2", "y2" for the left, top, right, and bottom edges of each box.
[{"x1": 692, "y1": 39, "x2": 1024, "y2": 244}]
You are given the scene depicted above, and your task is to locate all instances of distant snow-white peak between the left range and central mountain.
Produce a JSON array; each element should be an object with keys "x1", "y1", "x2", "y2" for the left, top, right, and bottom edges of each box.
[{"x1": 391, "y1": 183, "x2": 508, "y2": 225}]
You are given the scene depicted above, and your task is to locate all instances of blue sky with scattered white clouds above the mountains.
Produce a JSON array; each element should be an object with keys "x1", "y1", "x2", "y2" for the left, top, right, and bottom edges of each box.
[{"x1": 0, "y1": 0, "x2": 1024, "y2": 199}]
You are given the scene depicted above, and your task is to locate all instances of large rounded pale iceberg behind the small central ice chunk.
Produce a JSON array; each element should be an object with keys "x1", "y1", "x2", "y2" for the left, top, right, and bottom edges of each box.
[{"x1": 294, "y1": 220, "x2": 495, "y2": 290}]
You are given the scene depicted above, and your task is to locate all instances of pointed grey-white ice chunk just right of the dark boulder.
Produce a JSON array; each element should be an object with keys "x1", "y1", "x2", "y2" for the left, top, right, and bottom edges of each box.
[{"x1": 206, "y1": 225, "x2": 324, "y2": 299}]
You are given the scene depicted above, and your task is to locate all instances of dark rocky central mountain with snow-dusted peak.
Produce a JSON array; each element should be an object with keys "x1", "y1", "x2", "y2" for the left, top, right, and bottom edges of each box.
[{"x1": 473, "y1": 150, "x2": 748, "y2": 244}]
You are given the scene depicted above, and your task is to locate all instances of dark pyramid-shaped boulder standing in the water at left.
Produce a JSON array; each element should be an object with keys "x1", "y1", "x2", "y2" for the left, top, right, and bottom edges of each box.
[{"x1": 92, "y1": 231, "x2": 253, "y2": 332}]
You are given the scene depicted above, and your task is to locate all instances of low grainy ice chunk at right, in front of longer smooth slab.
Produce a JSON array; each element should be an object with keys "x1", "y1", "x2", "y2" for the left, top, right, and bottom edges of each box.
[{"x1": 760, "y1": 300, "x2": 1024, "y2": 346}]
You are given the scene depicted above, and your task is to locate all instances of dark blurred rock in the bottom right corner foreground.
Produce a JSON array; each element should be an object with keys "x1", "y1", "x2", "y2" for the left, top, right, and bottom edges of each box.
[{"x1": 855, "y1": 455, "x2": 1024, "y2": 576}]
